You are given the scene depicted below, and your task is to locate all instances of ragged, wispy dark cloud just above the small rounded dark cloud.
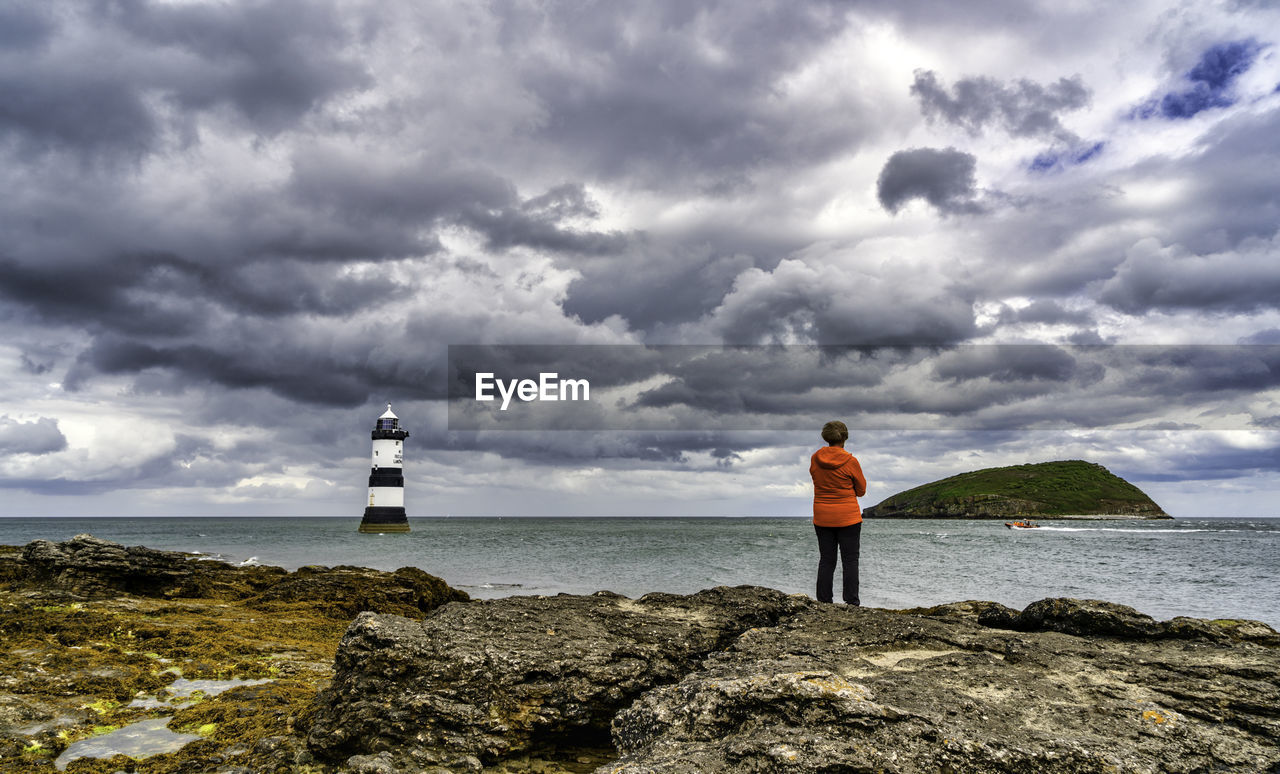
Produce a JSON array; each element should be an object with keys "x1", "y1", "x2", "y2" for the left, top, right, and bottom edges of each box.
[{"x1": 911, "y1": 70, "x2": 1091, "y2": 143}]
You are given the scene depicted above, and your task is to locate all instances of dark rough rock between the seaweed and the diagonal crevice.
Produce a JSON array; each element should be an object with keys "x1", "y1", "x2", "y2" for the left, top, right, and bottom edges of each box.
[{"x1": 310, "y1": 587, "x2": 814, "y2": 770}]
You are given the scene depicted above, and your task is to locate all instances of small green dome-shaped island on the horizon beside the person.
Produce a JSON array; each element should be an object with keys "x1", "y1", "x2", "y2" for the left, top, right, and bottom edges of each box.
[{"x1": 864, "y1": 459, "x2": 1172, "y2": 519}]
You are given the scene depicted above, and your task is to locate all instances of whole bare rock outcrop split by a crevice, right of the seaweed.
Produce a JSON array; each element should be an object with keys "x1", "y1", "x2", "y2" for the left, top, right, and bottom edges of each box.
[{"x1": 308, "y1": 587, "x2": 1280, "y2": 774}]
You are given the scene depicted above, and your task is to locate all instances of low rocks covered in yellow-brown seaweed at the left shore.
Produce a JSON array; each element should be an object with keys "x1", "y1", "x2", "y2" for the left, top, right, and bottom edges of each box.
[{"x1": 0, "y1": 535, "x2": 467, "y2": 774}]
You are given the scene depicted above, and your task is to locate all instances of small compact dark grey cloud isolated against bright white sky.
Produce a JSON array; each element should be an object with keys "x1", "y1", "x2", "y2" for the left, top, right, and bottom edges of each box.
[{"x1": 876, "y1": 148, "x2": 983, "y2": 215}]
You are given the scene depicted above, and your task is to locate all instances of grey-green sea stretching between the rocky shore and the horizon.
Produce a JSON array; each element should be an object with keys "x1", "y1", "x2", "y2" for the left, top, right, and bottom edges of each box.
[{"x1": 0, "y1": 517, "x2": 1280, "y2": 629}]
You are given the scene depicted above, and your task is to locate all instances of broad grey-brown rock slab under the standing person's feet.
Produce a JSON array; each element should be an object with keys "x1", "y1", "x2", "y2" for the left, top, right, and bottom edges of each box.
[{"x1": 598, "y1": 600, "x2": 1280, "y2": 774}]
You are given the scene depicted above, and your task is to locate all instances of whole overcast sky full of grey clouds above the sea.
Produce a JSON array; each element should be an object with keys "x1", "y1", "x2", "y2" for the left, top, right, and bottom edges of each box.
[{"x1": 0, "y1": 0, "x2": 1280, "y2": 518}]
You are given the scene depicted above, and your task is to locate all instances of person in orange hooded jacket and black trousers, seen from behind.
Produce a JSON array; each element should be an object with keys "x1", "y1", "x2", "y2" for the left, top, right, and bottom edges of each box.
[{"x1": 809, "y1": 421, "x2": 867, "y2": 605}]
